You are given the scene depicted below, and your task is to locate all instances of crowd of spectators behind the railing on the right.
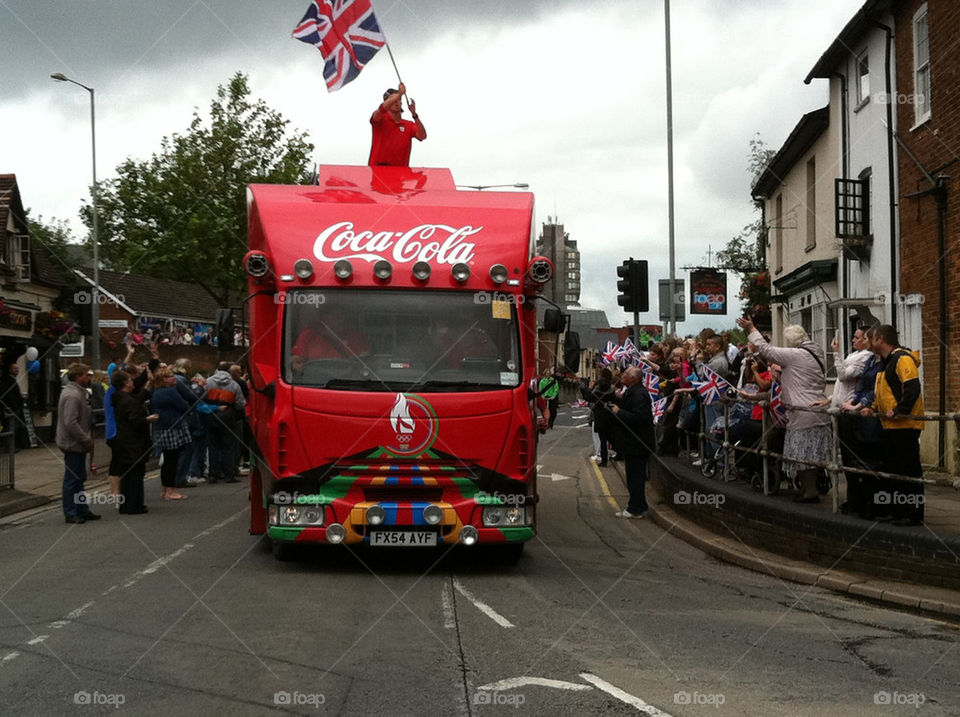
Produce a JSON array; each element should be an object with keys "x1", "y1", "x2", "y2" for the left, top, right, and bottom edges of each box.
[{"x1": 583, "y1": 319, "x2": 924, "y2": 526}]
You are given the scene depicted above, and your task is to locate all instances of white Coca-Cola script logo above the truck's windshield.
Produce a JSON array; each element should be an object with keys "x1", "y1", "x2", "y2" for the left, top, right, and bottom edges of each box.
[{"x1": 313, "y1": 222, "x2": 483, "y2": 264}]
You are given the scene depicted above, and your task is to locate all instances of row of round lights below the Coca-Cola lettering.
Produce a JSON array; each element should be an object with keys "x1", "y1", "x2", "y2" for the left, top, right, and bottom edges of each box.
[{"x1": 244, "y1": 251, "x2": 553, "y2": 286}]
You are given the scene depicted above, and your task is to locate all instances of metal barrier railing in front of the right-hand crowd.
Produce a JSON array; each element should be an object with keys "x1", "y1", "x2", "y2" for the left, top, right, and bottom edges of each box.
[{"x1": 688, "y1": 397, "x2": 960, "y2": 513}]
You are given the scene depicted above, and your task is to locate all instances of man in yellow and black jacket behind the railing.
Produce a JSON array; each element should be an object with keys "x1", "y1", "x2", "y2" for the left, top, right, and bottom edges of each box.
[{"x1": 870, "y1": 324, "x2": 923, "y2": 525}]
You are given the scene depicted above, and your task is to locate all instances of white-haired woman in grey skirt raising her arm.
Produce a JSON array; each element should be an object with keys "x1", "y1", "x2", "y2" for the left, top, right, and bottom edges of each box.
[{"x1": 737, "y1": 317, "x2": 833, "y2": 503}]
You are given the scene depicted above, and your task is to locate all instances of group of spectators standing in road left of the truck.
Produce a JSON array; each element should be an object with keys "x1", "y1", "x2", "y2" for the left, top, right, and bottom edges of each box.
[{"x1": 57, "y1": 336, "x2": 249, "y2": 523}]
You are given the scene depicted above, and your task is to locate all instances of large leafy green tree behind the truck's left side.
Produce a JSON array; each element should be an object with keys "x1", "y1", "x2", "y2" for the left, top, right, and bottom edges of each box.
[{"x1": 83, "y1": 72, "x2": 313, "y2": 306}]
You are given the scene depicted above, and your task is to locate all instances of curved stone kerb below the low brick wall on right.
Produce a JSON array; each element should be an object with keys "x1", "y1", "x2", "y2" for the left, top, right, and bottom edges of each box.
[{"x1": 611, "y1": 461, "x2": 960, "y2": 621}]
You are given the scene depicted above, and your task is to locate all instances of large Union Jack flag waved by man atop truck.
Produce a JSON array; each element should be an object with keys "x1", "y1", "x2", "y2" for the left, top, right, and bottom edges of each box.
[{"x1": 293, "y1": 0, "x2": 387, "y2": 92}]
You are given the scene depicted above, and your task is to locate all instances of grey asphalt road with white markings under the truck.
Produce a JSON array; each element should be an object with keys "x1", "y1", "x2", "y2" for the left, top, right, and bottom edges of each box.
[{"x1": 0, "y1": 409, "x2": 960, "y2": 716}]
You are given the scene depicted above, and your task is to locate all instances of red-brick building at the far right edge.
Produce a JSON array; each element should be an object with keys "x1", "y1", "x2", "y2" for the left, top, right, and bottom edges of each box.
[{"x1": 893, "y1": 0, "x2": 960, "y2": 471}]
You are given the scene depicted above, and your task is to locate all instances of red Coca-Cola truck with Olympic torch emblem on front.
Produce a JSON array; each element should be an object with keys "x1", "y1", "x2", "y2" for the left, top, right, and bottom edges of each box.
[{"x1": 244, "y1": 166, "x2": 553, "y2": 557}]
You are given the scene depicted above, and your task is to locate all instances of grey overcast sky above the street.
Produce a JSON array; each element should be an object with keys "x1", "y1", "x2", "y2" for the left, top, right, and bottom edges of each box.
[{"x1": 0, "y1": 0, "x2": 862, "y2": 332}]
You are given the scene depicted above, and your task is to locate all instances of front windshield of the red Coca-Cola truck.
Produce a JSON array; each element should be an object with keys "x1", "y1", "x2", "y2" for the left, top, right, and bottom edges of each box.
[{"x1": 282, "y1": 289, "x2": 522, "y2": 392}]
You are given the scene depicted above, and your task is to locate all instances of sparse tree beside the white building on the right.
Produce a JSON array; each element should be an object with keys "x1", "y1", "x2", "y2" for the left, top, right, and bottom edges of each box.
[{"x1": 717, "y1": 134, "x2": 776, "y2": 328}]
